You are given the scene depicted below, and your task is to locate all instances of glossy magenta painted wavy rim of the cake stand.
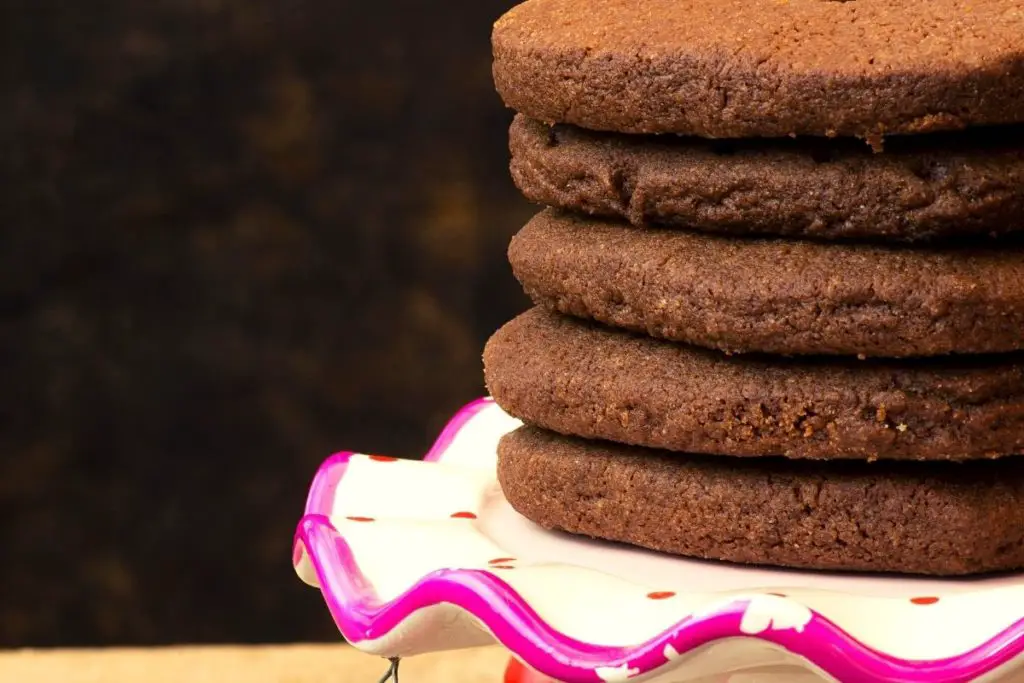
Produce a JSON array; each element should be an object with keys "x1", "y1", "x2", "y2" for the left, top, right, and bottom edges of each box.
[{"x1": 293, "y1": 398, "x2": 1024, "y2": 683}]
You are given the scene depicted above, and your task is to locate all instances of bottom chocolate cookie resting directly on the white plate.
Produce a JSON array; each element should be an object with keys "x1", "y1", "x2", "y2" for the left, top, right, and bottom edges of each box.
[{"x1": 498, "y1": 427, "x2": 1024, "y2": 575}]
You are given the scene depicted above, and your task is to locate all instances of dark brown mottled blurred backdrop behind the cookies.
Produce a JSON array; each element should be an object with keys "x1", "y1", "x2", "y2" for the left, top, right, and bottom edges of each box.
[{"x1": 6, "y1": 0, "x2": 530, "y2": 646}]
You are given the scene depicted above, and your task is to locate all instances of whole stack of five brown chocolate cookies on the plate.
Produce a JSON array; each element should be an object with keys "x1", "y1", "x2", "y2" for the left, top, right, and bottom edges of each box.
[{"x1": 484, "y1": 0, "x2": 1024, "y2": 575}]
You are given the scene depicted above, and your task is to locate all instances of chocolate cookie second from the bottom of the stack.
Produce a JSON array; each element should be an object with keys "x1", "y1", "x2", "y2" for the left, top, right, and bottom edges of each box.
[{"x1": 483, "y1": 308, "x2": 1024, "y2": 460}]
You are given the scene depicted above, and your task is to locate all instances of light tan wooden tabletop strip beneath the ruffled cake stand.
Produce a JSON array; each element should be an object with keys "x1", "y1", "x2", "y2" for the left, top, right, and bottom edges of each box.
[{"x1": 0, "y1": 644, "x2": 508, "y2": 683}]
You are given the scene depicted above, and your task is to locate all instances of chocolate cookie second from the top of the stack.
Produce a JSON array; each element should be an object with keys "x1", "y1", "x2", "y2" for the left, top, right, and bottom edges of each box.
[{"x1": 509, "y1": 115, "x2": 1024, "y2": 242}]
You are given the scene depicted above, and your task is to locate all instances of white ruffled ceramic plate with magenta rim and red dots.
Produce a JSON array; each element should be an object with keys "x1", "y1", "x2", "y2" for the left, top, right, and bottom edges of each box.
[{"x1": 293, "y1": 398, "x2": 1024, "y2": 683}]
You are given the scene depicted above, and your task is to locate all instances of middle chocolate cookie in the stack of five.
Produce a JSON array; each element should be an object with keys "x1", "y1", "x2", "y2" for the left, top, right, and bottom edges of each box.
[{"x1": 509, "y1": 210, "x2": 1024, "y2": 357}]
